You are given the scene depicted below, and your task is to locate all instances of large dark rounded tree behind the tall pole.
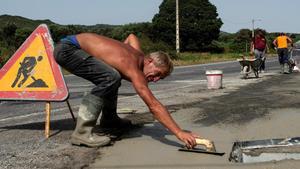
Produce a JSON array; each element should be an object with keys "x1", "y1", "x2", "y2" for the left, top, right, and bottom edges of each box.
[{"x1": 152, "y1": 0, "x2": 223, "y2": 51}]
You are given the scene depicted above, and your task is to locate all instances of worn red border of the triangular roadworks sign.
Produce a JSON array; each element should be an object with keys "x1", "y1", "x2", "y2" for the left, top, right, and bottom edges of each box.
[{"x1": 0, "y1": 24, "x2": 69, "y2": 101}]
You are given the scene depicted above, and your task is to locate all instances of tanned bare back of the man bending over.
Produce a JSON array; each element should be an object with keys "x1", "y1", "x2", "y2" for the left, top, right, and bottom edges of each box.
[{"x1": 76, "y1": 33, "x2": 144, "y2": 81}]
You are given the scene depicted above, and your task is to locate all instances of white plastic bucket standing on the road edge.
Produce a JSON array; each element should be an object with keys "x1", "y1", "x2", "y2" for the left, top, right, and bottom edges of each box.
[{"x1": 205, "y1": 70, "x2": 223, "y2": 89}]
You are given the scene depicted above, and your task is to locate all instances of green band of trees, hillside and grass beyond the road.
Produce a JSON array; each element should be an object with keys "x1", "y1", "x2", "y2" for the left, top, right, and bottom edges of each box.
[{"x1": 0, "y1": 0, "x2": 300, "y2": 68}]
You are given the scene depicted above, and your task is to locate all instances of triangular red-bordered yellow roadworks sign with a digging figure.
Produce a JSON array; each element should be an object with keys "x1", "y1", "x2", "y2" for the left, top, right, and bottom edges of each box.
[{"x1": 0, "y1": 24, "x2": 69, "y2": 101}]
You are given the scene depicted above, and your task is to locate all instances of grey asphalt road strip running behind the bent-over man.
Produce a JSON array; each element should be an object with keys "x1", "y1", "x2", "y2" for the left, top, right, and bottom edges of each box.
[{"x1": 0, "y1": 58, "x2": 278, "y2": 121}]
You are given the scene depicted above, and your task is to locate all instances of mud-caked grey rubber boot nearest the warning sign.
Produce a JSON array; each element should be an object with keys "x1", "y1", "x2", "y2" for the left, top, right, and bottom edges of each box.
[{"x1": 71, "y1": 94, "x2": 110, "y2": 147}]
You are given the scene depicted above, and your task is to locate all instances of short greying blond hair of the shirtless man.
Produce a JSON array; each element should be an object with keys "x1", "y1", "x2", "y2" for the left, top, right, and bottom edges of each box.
[{"x1": 147, "y1": 51, "x2": 174, "y2": 76}]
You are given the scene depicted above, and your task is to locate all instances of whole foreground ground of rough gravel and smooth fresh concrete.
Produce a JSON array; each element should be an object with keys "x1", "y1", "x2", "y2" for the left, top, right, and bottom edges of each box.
[{"x1": 0, "y1": 69, "x2": 300, "y2": 169}]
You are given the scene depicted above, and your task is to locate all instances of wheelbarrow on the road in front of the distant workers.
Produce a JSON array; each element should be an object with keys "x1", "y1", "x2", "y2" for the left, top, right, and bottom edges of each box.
[{"x1": 237, "y1": 58, "x2": 263, "y2": 79}]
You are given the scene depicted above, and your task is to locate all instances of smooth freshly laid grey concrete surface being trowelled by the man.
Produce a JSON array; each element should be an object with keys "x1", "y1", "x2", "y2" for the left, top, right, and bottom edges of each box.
[{"x1": 89, "y1": 70, "x2": 300, "y2": 169}]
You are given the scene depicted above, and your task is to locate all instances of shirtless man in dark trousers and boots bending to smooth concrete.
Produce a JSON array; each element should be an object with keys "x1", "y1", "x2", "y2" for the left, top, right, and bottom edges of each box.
[{"x1": 54, "y1": 33, "x2": 198, "y2": 148}]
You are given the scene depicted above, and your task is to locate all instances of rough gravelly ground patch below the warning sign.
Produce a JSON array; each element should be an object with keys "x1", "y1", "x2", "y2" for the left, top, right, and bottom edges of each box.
[{"x1": 0, "y1": 117, "x2": 98, "y2": 169}]
